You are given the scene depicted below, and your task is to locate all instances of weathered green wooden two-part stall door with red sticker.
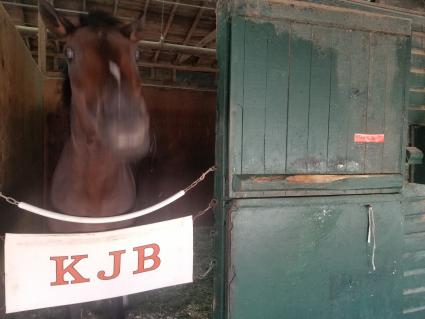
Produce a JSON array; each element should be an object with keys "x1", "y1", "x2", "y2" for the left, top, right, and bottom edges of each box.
[{"x1": 216, "y1": 0, "x2": 411, "y2": 319}]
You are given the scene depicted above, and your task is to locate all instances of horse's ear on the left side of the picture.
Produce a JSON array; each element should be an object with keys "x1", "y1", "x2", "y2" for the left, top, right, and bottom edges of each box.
[{"x1": 38, "y1": 0, "x2": 75, "y2": 38}]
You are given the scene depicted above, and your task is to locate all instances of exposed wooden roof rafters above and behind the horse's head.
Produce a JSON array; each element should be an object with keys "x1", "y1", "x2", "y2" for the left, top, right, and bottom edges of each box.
[{"x1": 0, "y1": 0, "x2": 217, "y2": 85}]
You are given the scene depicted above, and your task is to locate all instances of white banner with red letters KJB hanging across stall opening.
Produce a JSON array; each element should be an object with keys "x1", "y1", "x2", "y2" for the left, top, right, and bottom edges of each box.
[{"x1": 5, "y1": 216, "x2": 193, "y2": 313}]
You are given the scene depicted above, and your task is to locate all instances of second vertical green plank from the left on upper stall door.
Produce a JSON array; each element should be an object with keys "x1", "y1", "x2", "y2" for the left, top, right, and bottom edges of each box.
[{"x1": 242, "y1": 20, "x2": 267, "y2": 174}]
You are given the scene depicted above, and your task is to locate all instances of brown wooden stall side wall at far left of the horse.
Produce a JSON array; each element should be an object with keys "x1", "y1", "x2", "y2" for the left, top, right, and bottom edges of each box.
[{"x1": 0, "y1": 5, "x2": 44, "y2": 220}]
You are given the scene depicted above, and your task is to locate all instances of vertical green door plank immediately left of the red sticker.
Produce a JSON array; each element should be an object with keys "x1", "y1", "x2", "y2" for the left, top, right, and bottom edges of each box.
[{"x1": 326, "y1": 29, "x2": 353, "y2": 173}]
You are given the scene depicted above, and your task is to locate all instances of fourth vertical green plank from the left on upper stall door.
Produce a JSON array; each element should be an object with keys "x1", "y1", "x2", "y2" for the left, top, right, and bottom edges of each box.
[{"x1": 286, "y1": 23, "x2": 312, "y2": 174}]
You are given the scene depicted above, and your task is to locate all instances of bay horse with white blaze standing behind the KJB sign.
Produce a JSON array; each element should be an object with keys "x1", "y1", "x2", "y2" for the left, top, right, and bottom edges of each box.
[{"x1": 39, "y1": 0, "x2": 150, "y2": 318}]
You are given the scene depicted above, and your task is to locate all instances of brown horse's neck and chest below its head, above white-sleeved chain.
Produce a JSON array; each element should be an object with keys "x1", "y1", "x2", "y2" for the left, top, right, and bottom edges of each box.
[{"x1": 52, "y1": 139, "x2": 135, "y2": 216}]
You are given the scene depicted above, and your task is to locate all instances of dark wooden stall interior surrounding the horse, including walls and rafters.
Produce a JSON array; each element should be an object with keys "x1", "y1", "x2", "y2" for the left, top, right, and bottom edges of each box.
[{"x1": 0, "y1": 0, "x2": 425, "y2": 319}]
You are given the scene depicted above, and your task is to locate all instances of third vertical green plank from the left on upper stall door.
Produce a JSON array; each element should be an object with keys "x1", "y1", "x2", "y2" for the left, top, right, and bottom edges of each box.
[{"x1": 264, "y1": 22, "x2": 290, "y2": 174}]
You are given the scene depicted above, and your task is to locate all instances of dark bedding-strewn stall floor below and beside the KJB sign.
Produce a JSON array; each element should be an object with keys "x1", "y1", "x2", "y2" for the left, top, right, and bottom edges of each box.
[{"x1": 1, "y1": 226, "x2": 214, "y2": 319}]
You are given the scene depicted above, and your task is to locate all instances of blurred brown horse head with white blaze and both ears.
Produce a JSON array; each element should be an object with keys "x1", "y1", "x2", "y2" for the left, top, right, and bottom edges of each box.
[{"x1": 40, "y1": 0, "x2": 149, "y2": 160}]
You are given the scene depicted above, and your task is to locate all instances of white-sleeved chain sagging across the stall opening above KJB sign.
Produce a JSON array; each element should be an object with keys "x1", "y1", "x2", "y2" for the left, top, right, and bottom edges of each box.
[{"x1": 0, "y1": 166, "x2": 215, "y2": 224}]
